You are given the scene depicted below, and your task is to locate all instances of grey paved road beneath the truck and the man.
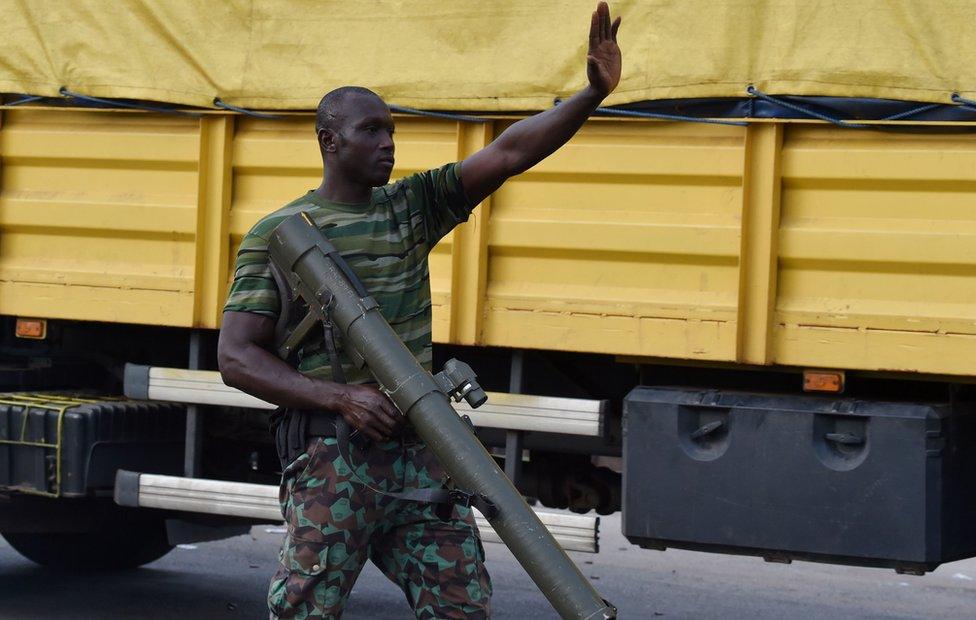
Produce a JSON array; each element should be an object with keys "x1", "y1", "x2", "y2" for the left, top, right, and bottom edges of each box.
[{"x1": 0, "y1": 516, "x2": 976, "y2": 620}]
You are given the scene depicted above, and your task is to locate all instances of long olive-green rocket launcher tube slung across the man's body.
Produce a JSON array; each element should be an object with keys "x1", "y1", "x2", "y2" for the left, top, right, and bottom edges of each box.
[{"x1": 269, "y1": 213, "x2": 616, "y2": 619}]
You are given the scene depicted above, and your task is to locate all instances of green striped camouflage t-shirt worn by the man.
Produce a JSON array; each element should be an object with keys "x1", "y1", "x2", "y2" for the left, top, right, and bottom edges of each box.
[{"x1": 224, "y1": 163, "x2": 473, "y2": 383}]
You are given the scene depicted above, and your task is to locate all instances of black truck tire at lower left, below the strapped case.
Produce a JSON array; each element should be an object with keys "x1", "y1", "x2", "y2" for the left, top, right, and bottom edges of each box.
[{"x1": 3, "y1": 518, "x2": 173, "y2": 570}]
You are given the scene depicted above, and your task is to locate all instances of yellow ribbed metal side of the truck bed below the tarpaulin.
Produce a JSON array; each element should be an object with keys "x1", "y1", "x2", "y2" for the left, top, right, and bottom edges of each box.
[{"x1": 0, "y1": 109, "x2": 976, "y2": 375}]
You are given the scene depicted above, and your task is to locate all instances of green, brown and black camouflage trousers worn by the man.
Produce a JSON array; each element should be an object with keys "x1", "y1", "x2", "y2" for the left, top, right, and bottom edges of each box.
[{"x1": 268, "y1": 437, "x2": 491, "y2": 620}]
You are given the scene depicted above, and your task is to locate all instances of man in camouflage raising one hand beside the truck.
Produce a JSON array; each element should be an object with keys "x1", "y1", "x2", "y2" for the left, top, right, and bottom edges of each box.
[{"x1": 218, "y1": 2, "x2": 621, "y2": 618}]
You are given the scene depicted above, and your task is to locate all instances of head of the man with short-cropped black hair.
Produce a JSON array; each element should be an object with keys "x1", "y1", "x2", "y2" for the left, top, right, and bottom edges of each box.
[{"x1": 315, "y1": 86, "x2": 394, "y2": 187}]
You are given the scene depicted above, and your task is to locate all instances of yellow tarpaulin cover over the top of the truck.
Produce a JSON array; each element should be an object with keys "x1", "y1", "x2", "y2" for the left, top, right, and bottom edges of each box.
[{"x1": 0, "y1": 0, "x2": 976, "y2": 111}]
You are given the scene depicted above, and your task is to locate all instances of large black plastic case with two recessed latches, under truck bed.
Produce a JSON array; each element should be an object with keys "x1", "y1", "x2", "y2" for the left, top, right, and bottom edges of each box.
[{"x1": 623, "y1": 388, "x2": 976, "y2": 572}]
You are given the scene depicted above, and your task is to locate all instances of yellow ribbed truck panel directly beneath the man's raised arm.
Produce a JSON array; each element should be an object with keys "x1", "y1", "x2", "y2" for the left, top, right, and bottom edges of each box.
[{"x1": 481, "y1": 121, "x2": 743, "y2": 360}]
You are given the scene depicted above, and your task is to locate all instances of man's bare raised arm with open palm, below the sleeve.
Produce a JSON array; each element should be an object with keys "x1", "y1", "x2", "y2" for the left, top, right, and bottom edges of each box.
[{"x1": 461, "y1": 2, "x2": 620, "y2": 204}]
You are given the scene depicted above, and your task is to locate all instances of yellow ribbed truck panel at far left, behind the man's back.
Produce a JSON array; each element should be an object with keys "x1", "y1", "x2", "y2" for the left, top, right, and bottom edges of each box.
[{"x1": 0, "y1": 110, "x2": 197, "y2": 325}]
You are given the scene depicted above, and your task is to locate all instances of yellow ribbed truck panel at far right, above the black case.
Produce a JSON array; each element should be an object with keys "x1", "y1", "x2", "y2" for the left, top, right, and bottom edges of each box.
[{"x1": 774, "y1": 126, "x2": 976, "y2": 374}]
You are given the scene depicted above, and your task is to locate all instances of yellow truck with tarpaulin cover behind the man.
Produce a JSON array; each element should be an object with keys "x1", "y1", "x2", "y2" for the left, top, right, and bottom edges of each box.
[{"x1": 0, "y1": 0, "x2": 976, "y2": 573}]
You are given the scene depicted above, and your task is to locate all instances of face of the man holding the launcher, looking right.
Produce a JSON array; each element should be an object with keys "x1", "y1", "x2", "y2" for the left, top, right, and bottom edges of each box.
[{"x1": 333, "y1": 95, "x2": 394, "y2": 187}]
